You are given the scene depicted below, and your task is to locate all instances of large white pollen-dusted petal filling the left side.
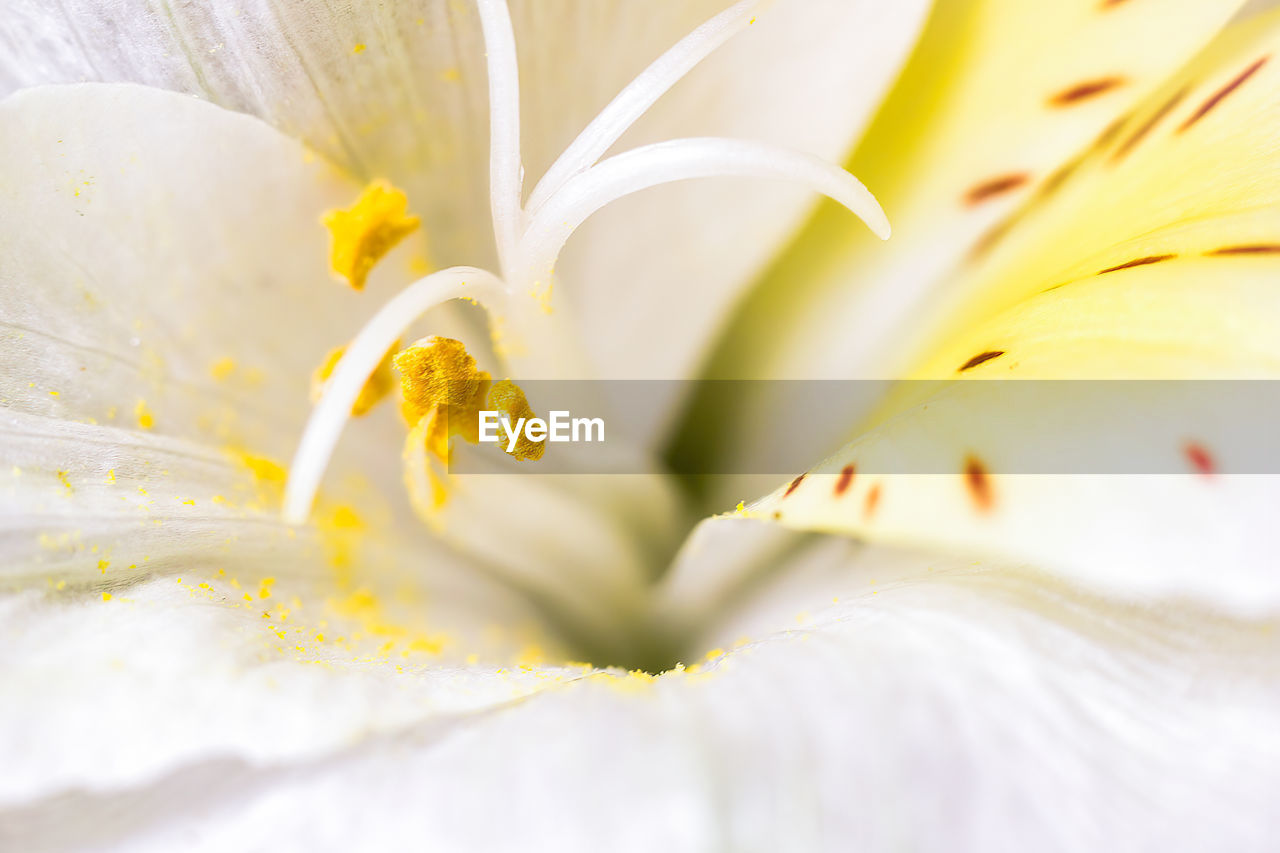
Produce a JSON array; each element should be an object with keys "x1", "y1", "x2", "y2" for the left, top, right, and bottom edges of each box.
[{"x1": 0, "y1": 86, "x2": 576, "y2": 788}]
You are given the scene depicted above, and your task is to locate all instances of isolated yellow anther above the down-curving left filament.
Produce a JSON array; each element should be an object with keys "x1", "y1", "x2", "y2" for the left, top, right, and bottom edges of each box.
[{"x1": 324, "y1": 181, "x2": 421, "y2": 291}]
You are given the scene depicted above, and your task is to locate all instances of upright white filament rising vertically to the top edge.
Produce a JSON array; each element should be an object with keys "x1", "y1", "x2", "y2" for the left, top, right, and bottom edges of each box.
[{"x1": 476, "y1": 0, "x2": 525, "y2": 275}]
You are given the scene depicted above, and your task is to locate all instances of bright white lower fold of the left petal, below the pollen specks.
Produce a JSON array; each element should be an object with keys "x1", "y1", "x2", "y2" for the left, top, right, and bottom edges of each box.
[{"x1": 0, "y1": 567, "x2": 581, "y2": 809}]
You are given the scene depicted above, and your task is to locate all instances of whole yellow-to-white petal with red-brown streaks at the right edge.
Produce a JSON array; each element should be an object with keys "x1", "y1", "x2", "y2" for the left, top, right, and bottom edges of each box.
[{"x1": 750, "y1": 13, "x2": 1280, "y2": 613}]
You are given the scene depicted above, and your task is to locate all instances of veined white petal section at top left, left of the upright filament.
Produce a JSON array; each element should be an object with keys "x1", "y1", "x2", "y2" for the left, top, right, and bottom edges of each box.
[{"x1": 0, "y1": 0, "x2": 492, "y2": 265}]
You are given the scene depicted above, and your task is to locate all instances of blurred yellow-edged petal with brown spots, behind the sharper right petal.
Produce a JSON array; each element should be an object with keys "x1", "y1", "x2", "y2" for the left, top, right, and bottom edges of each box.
[{"x1": 682, "y1": 0, "x2": 1252, "y2": 481}]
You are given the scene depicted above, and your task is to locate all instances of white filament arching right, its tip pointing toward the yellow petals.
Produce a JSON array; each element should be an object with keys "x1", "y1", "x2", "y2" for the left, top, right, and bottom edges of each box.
[{"x1": 520, "y1": 138, "x2": 890, "y2": 277}]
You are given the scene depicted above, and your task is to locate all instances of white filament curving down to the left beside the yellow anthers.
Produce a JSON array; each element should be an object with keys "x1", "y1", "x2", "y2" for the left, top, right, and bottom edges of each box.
[{"x1": 284, "y1": 266, "x2": 507, "y2": 524}]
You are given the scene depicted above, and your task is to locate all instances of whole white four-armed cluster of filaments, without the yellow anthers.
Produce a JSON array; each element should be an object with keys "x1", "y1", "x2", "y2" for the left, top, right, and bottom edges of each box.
[{"x1": 284, "y1": 0, "x2": 890, "y2": 524}]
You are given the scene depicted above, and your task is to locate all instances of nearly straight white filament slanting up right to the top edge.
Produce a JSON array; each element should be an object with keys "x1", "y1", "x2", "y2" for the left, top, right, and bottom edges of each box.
[{"x1": 527, "y1": 0, "x2": 763, "y2": 218}]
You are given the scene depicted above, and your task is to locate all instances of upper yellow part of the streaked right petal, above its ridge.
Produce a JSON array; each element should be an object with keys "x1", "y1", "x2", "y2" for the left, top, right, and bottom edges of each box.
[{"x1": 940, "y1": 13, "x2": 1280, "y2": 348}]
